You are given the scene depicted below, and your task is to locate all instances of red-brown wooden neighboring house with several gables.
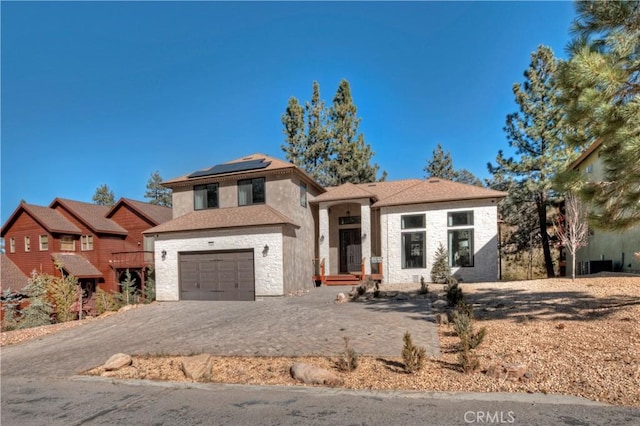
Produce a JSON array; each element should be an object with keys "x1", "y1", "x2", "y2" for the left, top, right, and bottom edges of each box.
[{"x1": 1, "y1": 198, "x2": 171, "y2": 307}]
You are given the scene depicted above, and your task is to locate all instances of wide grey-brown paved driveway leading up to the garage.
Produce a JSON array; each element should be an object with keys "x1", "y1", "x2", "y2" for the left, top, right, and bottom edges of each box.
[{"x1": 0, "y1": 287, "x2": 439, "y2": 377}]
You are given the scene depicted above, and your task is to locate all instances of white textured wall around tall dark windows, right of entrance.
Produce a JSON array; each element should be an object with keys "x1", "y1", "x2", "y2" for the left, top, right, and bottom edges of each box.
[{"x1": 380, "y1": 200, "x2": 498, "y2": 284}]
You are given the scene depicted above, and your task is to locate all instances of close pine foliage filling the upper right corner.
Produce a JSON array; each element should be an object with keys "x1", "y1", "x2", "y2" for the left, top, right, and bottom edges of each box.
[{"x1": 560, "y1": 0, "x2": 640, "y2": 230}]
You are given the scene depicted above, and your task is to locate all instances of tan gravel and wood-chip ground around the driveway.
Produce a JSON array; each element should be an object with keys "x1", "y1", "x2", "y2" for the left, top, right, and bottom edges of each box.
[{"x1": 2, "y1": 276, "x2": 640, "y2": 407}]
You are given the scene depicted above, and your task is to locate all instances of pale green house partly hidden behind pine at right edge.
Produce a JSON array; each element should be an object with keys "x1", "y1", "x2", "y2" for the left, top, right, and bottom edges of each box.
[{"x1": 567, "y1": 140, "x2": 640, "y2": 276}]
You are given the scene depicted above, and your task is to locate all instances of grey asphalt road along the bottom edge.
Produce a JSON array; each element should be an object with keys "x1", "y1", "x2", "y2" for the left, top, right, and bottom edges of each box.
[{"x1": 2, "y1": 378, "x2": 640, "y2": 426}]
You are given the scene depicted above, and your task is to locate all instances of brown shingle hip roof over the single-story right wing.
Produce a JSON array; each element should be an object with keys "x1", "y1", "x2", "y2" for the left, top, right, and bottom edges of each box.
[{"x1": 373, "y1": 178, "x2": 508, "y2": 207}]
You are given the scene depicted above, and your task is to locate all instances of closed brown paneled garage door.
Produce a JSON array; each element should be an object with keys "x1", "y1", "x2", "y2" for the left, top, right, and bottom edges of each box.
[{"x1": 179, "y1": 250, "x2": 255, "y2": 300}]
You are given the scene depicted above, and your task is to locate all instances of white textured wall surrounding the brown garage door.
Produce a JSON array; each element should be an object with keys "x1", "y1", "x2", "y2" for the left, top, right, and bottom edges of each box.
[{"x1": 155, "y1": 226, "x2": 284, "y2": 301}]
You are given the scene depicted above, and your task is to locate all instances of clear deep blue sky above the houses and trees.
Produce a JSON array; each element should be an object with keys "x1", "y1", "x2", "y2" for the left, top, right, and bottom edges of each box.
[{"x1": 0, "y1": 1, "x2": 574, "y2": 223}]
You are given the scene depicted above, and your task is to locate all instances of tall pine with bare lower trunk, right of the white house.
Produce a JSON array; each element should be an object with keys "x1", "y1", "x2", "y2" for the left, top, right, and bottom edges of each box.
[{"x1": 489, "y1": 46, "x2": 573, "y2": 277}]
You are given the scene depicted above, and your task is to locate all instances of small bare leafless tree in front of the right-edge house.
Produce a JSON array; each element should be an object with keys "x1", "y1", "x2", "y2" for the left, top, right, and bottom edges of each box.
[{"x1": 554, "y1": 192, "x2": 589, "y2": 280}]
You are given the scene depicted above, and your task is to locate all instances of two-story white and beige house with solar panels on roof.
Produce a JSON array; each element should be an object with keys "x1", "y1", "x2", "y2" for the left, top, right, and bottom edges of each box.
[{"x1": 145, "y1": 154, "x2": 506, "y2": 300}]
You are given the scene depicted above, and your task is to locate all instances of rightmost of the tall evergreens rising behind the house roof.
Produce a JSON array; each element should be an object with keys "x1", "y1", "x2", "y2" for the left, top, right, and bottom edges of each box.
[{"x1": 326, "y1": 79, "x2": 386, "y2": 185}]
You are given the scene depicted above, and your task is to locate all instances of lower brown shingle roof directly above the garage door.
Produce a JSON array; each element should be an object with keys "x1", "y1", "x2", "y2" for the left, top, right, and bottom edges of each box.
[{"x1": 143, "y1": 205, "x2": 298, "y2": 234}]
